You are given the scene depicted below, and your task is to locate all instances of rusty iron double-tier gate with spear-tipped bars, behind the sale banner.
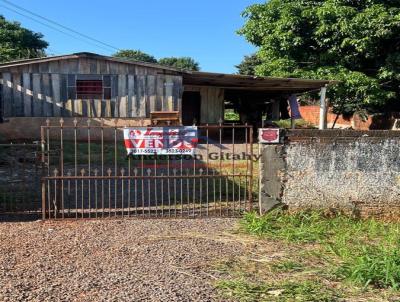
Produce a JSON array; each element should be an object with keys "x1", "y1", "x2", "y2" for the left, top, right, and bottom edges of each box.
[{"x1": 41, "y1": 119, "x2": 254, "y2": 219}]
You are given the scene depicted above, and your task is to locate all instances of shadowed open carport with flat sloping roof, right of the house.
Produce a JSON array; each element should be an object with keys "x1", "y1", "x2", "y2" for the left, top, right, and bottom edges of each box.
[{"x1": 182, "y1": 71, "x2": 337, "y2": 125}]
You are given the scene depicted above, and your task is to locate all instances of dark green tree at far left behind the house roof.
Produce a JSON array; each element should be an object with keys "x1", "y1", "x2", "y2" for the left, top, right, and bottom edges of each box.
[{"x1": 0, "y1": 15, "x2": 49, "y2": 62}]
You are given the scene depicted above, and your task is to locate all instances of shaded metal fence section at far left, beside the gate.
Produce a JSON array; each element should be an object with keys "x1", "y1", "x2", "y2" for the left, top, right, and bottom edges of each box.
[{"x1": 0, "y1": 143, "x2": 42, "y2": 217}]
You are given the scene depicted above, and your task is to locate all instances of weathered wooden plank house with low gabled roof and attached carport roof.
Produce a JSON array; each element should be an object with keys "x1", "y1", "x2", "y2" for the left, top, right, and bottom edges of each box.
[{"x1": 0, "y1": 53, "x2": 329, "y2": 138}]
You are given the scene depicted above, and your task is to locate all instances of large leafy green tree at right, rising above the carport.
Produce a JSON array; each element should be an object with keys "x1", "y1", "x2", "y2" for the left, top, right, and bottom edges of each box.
[{"x1": 239, "y1": 0, "x2": 400, "y2": 113}]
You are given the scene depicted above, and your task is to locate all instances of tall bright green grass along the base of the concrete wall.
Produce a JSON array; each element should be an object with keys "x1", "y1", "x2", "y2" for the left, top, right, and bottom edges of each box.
[{"x1": 241, "y1": 209, "x2": 400, "y2": 290}]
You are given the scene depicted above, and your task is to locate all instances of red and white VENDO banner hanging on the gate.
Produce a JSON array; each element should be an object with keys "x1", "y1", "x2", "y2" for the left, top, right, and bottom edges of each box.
[{"x1": 124, "y1": 126, "x2": 198, "y2": 155}]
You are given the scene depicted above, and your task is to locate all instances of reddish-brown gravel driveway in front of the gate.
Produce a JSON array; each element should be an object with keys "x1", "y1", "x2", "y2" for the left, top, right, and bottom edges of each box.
[{"x1": 0, "y1": 218, "x2": 244, "y2": 301}]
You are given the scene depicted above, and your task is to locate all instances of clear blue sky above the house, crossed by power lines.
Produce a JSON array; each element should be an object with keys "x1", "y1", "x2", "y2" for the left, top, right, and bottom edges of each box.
[{"x1": 0, "y1": 0, "x2": 264, "y2": 73}]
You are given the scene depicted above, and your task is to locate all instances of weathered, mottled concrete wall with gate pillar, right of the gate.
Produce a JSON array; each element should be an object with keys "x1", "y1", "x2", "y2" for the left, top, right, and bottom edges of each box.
[{"x1": 261, "y1": 130, "x2": 400, "y2": 218}]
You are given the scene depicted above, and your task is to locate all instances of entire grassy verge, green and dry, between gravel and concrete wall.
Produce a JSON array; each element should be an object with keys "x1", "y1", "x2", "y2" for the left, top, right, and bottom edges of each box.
[{"x1": 217, "y1": 209, "x2": 400, "y2": 301}]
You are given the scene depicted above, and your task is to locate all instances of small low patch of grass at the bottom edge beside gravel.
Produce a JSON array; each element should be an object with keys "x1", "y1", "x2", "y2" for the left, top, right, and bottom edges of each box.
[{"x1": 217, "y1": 279, "x2": 339, "y2": 302}]
